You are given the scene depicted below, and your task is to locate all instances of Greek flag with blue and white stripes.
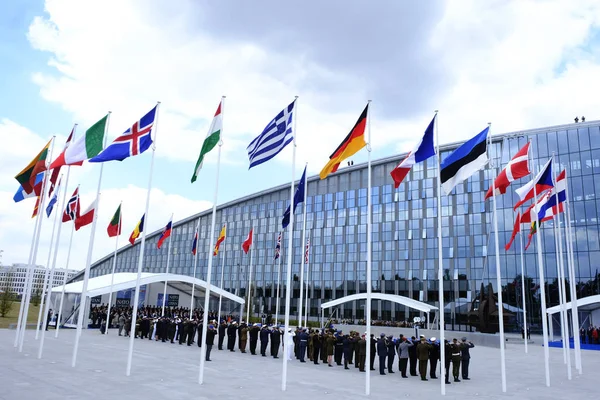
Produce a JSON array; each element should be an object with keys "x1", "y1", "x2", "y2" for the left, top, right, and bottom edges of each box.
[{"x1": 246, "y1": 100, "x2": 296, "y2": 169}]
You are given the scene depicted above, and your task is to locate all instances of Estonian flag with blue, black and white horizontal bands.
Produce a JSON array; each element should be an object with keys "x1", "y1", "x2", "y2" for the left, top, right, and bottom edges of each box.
[{"x1": 440, "y1": 127, "x2": 490, "y2": 195}]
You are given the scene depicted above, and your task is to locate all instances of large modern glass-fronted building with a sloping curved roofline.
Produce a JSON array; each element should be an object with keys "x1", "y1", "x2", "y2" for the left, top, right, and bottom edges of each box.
[{"x1": 71, "y1": 121, "x2": 600, "y2": 330}]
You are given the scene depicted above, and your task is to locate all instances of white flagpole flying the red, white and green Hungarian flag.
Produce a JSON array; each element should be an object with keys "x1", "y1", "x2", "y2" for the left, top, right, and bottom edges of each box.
[{"x1": 198, "y1": 96, "x2": 227, "y2": 385}]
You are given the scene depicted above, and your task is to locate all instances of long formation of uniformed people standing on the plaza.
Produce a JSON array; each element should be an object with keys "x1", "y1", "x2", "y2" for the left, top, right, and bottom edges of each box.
[{"x1": 90, "y1": 306, "x2": 474, "y2": 384}]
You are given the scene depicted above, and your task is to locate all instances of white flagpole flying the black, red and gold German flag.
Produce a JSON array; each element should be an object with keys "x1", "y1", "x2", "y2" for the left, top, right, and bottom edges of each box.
[{"x1": 365, "y1": 100, "x2": 373, "y2": 396}]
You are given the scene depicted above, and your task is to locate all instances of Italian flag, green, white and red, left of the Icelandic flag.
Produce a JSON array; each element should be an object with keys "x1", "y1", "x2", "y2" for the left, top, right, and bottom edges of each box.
[{"x1": 50, "y1": 115, "x2": 108, "y2": 169}]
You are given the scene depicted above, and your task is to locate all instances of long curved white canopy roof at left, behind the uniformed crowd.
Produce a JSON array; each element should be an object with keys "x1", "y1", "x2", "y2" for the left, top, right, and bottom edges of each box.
[{"x1": 52, "y1": 272, "x2": 245, "y2": 304}]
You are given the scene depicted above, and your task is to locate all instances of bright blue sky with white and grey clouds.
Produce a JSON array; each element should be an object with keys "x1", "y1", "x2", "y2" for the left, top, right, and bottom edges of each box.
[{"x1": 0, "y1": 0, "x2": 600, "y2": 269}]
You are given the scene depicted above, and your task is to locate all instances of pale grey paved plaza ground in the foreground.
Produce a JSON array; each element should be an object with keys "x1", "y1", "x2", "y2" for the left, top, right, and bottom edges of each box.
[{"x1": 0, "y1": 330, "x2": 600, "y2": 400}]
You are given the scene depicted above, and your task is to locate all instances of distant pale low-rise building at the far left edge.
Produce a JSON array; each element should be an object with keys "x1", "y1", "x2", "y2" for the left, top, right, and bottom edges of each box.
[{"x1": 0, "y1": 264, "x2": 78, "y2": 296}]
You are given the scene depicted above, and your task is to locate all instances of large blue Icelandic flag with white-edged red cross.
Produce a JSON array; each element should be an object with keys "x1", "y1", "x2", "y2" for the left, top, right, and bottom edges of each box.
[{"x1": 89, "y1": 105, "x2": 158, "y2": 162}]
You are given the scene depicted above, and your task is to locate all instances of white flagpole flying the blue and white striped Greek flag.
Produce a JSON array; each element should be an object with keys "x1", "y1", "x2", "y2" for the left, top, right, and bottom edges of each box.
[{"x1": 277, "y1": 96, "x2": 298, "y2": 392}]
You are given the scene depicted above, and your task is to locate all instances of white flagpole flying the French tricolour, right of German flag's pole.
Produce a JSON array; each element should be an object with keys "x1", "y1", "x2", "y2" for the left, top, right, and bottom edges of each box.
[{"x1": 435, "y1": 110, "x2": 446, "y2": 396}]
